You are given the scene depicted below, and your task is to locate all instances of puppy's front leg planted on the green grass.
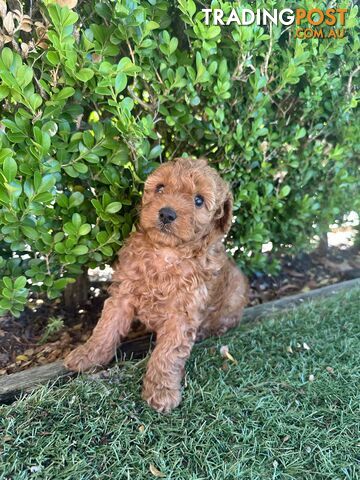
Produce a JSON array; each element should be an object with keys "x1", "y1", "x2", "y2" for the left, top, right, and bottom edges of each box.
[{"x1": 143, "y1": 317, "x2": 196, "y2": 412}]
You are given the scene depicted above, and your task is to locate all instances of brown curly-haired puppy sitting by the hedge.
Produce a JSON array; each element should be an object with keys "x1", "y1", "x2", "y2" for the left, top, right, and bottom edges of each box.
[{"x1": 65, "y1": 158, "x2": 248, "y2": 412}]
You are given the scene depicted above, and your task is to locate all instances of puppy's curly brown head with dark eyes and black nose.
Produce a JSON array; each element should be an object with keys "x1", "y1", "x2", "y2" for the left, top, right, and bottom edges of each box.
[{"x1": 140, "y1": 158, "x2": 232, "y2": 246}]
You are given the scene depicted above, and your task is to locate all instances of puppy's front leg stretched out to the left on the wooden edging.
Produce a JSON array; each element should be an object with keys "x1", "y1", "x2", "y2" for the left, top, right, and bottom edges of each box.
[{"x1": 64, "y1": 295, "x2": 134, "y2": 371}]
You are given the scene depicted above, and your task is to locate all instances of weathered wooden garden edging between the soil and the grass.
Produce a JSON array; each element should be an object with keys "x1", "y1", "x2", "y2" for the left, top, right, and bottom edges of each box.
[{"x1": 0, "y1": 278, "x2": 360, "y2": 403}]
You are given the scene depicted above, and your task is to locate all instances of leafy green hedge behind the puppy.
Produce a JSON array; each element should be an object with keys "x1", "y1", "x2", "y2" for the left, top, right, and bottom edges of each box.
[{"x1": 0, "y1": 0, "x2": 360, "y2": 315}]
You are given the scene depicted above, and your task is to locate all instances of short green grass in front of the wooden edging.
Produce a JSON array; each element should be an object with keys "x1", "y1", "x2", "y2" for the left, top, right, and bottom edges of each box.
[{"x1": 0, "y1": 289, "x2": 360, "y2": 480}]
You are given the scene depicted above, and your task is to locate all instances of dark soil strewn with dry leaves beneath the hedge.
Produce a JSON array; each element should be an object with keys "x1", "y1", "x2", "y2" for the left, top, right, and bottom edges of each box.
[{"x1": 0, "y1": 247, "x2": 360, "y2": 375}]
